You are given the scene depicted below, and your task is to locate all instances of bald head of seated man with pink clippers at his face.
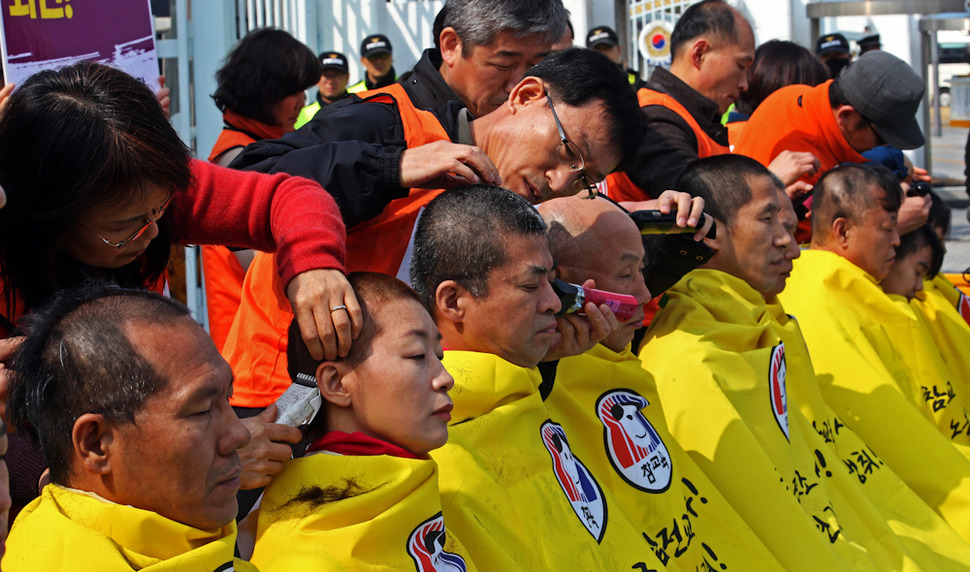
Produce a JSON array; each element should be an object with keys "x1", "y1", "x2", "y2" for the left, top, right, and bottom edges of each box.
[{"x1": 539, "y1": 197, "x2": 651, "y2": 352}]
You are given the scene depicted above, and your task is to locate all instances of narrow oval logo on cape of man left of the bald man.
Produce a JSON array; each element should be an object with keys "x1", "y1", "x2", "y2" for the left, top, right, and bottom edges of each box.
[{"x1": 539, "y1": 421, "x2": 607, "y2": 542}]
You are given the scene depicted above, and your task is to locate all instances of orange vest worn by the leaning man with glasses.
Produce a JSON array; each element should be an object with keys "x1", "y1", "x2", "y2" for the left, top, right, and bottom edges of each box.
[{"x1": 222, "y1": 84, "x2": 450, "y2": 407}]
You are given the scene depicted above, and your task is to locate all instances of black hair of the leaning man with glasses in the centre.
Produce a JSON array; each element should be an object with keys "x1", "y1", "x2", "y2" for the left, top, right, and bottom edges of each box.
[{"x1": 525, "y1": 48, "x2": 646, "y2": 168}]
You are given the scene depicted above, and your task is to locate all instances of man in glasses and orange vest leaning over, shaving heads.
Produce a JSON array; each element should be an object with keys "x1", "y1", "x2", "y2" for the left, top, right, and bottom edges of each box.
[{"x1": 223, "y1": 49, "x2": 680, "y2": 428}]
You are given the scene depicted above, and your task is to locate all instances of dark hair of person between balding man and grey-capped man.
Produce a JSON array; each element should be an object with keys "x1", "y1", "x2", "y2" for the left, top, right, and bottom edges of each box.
[{"x1": 737, "y1": 40, "x2": 829, "y2": 115}]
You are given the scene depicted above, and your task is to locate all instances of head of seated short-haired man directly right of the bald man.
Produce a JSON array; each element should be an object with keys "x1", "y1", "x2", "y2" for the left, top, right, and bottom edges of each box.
[{"x1": 679, "y1": 155, "x2": 794, "y2": 294}]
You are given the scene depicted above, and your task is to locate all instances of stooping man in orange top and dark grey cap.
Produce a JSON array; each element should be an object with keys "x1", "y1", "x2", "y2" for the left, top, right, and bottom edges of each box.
[{"x1": 734, "y1": 51, "x2": 929, "y2": 240}]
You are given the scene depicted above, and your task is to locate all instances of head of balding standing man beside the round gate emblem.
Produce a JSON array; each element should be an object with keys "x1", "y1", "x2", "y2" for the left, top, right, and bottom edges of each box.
[{"x1": 670, "y1": 0, "x2": 755, "y2": 113}]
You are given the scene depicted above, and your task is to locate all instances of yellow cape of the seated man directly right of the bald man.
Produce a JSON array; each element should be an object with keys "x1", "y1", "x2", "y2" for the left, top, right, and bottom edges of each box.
[{"x1": 640, "y1": 269, "x2": 936, "y2": 570}]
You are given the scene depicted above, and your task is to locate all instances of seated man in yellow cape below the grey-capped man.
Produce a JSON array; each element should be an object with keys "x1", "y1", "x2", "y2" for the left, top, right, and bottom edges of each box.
[{"x1": 779, "y1": 165, "x2": 970, "y2": 537}]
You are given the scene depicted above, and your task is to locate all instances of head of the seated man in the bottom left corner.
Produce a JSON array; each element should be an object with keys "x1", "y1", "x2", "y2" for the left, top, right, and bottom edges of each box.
[{"x1": 7, "y1": 287, "x2": 250, "y2": 532}]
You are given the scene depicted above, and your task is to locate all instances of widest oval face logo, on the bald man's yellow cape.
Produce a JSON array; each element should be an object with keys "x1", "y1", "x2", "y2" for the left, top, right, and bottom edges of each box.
[{"x1": 596, "y1": 389, "x2": 673, "y2": 493}]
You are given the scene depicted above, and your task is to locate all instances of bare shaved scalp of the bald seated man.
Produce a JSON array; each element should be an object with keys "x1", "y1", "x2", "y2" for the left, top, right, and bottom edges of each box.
[{"x1": 538, "y1": 196, "x2": 640, "y2": 268}]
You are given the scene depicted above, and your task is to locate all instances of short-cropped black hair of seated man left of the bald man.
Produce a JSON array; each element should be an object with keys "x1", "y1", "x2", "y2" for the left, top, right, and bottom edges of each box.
[{"x1": 411, "y1": 184, "x2": 544, "y2": 316}]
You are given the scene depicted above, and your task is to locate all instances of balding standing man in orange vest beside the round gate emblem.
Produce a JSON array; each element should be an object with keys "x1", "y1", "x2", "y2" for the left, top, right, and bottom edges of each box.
[{"x1": 607, "y1": 0, "x2": 755, "y2": 201}]
